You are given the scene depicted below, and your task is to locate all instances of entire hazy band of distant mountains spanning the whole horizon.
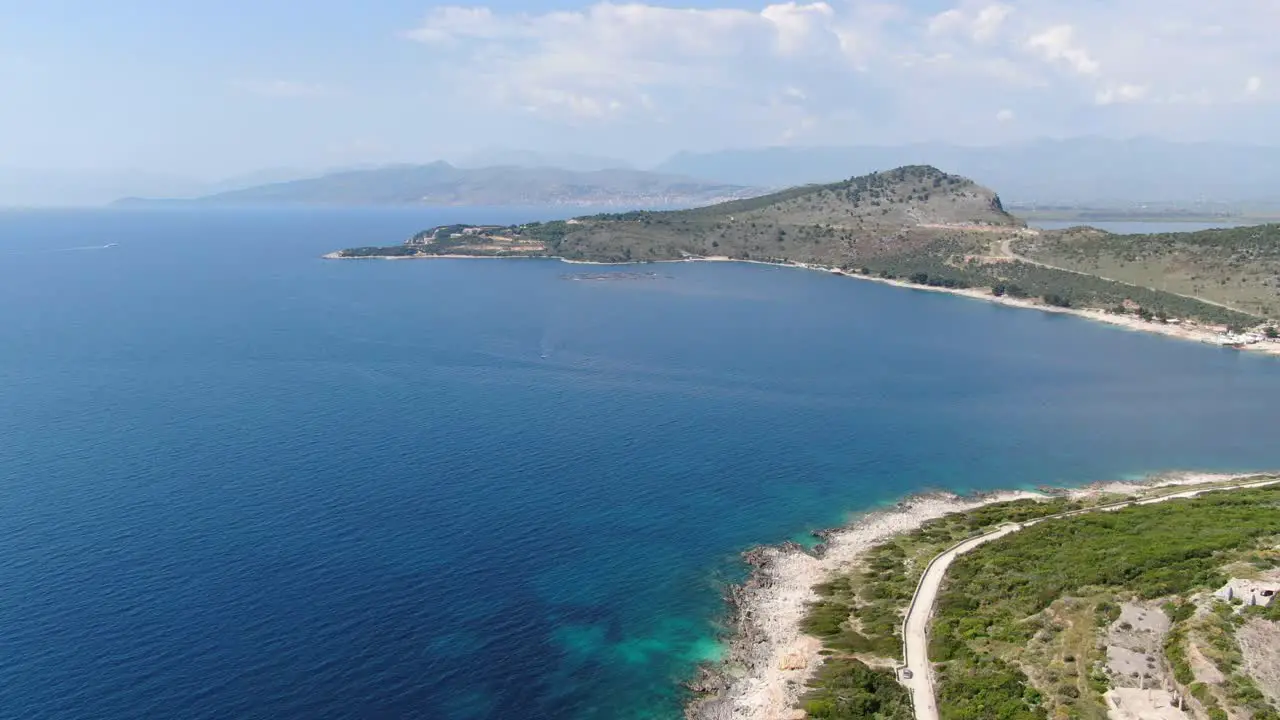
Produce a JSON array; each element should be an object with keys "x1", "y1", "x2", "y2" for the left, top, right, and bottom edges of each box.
[{"x1": 0, "y1": 138, "x2": 1280, "y2": 208}]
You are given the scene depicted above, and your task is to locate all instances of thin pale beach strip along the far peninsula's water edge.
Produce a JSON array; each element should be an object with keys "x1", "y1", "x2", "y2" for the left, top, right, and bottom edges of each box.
[{"x1": 323, "y1": 251, "x2": 1280, "y2": 356}]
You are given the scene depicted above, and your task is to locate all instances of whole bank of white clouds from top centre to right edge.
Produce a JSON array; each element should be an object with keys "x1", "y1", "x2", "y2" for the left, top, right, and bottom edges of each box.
[{"x1": 404, "y1": 0, "x2": 1280, "y2": 145}]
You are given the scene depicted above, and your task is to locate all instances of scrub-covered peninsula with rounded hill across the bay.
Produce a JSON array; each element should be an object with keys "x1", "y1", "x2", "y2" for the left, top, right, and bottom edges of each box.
[{"x1": 326, "y1": 165, "x2": 1280, "y2": 354}]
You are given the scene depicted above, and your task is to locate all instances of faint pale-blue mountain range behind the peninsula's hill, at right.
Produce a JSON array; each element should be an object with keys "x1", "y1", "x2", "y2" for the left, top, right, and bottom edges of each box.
[{"x1": 654, "y1": 138, "x2": 1280, "y2": 206}]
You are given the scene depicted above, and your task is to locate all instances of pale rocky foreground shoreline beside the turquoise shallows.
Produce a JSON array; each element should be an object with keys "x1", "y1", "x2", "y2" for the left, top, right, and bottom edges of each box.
[{"x1": 685, "y1": 473, "x2": 1257, "y2": 720}]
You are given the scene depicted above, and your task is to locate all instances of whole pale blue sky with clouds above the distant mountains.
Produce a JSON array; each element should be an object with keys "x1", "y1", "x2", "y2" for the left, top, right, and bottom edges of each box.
[{"x1": 0, "y1": 0, "x2": 1280, "y2": 178}]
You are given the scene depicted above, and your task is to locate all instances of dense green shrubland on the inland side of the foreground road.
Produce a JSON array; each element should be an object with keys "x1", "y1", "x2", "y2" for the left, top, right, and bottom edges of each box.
[{"x1": 929, "y1": 488, "x2": 1280, "y2": 720}]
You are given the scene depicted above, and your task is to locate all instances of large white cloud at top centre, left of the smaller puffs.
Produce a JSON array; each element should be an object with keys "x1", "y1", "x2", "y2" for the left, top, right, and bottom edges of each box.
[{"x1": 407, "y1": 1, "x2": 851, "y2": 122}]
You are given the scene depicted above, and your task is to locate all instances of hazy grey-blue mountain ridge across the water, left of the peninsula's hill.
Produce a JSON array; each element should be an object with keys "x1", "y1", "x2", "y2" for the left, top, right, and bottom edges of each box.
[{"x1": 116, "y1": 163, "x2": 764, "y2": 208}]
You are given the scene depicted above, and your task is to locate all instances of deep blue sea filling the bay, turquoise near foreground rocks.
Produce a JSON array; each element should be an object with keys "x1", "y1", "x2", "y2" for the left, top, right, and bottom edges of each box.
[{"x1": 0, "y1": 209, "x2": 1280, "y2": 720}]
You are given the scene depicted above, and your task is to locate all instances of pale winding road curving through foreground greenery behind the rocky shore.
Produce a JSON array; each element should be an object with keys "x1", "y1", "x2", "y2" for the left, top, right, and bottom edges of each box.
[{"x1": 899, "y1": 478, "x2": 1280, "y2": 720}]
